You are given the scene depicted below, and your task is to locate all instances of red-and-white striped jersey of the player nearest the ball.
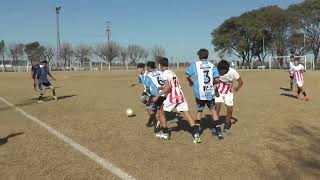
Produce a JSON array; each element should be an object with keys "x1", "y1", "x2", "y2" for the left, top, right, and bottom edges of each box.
[{"x1": 162, "y1": 69, "x2": 185, "y2": 104}]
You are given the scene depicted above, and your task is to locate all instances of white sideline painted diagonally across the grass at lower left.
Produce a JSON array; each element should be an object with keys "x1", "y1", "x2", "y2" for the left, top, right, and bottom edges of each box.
[{"x1": 0, "y1": 97, "x2": 135, "y2": 180}]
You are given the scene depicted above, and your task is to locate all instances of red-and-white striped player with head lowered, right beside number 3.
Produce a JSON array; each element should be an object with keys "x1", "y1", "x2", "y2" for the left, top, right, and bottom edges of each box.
[{"x1": 216, "y1": 60, "x2": 243, "y2": 134}]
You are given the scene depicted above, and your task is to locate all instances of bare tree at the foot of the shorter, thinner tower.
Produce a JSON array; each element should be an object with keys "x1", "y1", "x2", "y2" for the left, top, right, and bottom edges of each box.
[{"x1": 94, "y1": 42, "x2": 120, "y2": 64}]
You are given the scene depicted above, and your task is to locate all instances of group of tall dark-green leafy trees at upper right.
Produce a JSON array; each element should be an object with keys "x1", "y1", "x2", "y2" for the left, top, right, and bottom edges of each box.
[{"x1": 211, "y1": 0, "x2": 320, "y2": 67}]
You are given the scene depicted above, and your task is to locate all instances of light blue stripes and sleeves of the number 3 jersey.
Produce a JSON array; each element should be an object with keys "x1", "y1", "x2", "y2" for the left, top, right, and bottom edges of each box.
[{"x1": 186, "y1": 60, "x2": 220, "y2": 100}]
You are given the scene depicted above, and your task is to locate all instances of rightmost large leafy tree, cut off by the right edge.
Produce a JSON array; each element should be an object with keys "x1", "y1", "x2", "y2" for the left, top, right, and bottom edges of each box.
[{"x1": 288, "y1": 0, "x2": 320, "y2": 62}]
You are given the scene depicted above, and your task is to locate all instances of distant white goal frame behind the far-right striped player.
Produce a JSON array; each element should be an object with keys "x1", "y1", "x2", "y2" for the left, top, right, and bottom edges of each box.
[{"x1": 269, "y1": 56, "x2": 314, "y2": 70}]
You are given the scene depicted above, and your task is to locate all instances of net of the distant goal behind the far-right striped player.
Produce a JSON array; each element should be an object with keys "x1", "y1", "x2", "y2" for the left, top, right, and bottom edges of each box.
[{"x1": 269, "y1": 56, "x2": 314, "y2": 70}]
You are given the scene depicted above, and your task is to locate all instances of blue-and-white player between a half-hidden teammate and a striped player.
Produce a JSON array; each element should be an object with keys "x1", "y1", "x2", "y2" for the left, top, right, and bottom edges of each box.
[{"x1": 144, "y1": 61, "x2": 166, "y2": 127}]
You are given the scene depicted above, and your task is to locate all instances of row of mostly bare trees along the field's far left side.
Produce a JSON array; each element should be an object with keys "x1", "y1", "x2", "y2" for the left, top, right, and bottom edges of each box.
[{"x1": 0, "y1": 40, "x2": 166, "y2": 71}]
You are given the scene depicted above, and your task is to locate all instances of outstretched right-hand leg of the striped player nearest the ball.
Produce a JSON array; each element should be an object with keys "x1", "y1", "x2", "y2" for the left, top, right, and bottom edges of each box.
[{"x1": 176, "y1": 101, "x2": 202, "y2": 144}]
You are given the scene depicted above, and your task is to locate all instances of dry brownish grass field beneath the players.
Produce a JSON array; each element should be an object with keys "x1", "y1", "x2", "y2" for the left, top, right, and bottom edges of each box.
[{"x1": 0, "y1": 71, "x2": 320, "y2": 180}]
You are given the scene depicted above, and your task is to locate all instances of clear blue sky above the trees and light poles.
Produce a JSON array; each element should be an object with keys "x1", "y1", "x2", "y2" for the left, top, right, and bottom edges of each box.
[{"x1": 0, "y1": 0, "x2": 303, "y2": 61}]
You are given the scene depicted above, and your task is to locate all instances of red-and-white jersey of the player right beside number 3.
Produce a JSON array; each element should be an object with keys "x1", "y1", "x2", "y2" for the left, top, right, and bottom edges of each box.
[{"x1": 217, "y1": 68, "x2": 240, "y2": 94}]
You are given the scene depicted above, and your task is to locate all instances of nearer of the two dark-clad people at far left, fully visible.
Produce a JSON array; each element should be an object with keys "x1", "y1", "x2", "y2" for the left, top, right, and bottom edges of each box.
[{"x1": 37, "y1": 61, "x2": 58, "y2": 102}]
